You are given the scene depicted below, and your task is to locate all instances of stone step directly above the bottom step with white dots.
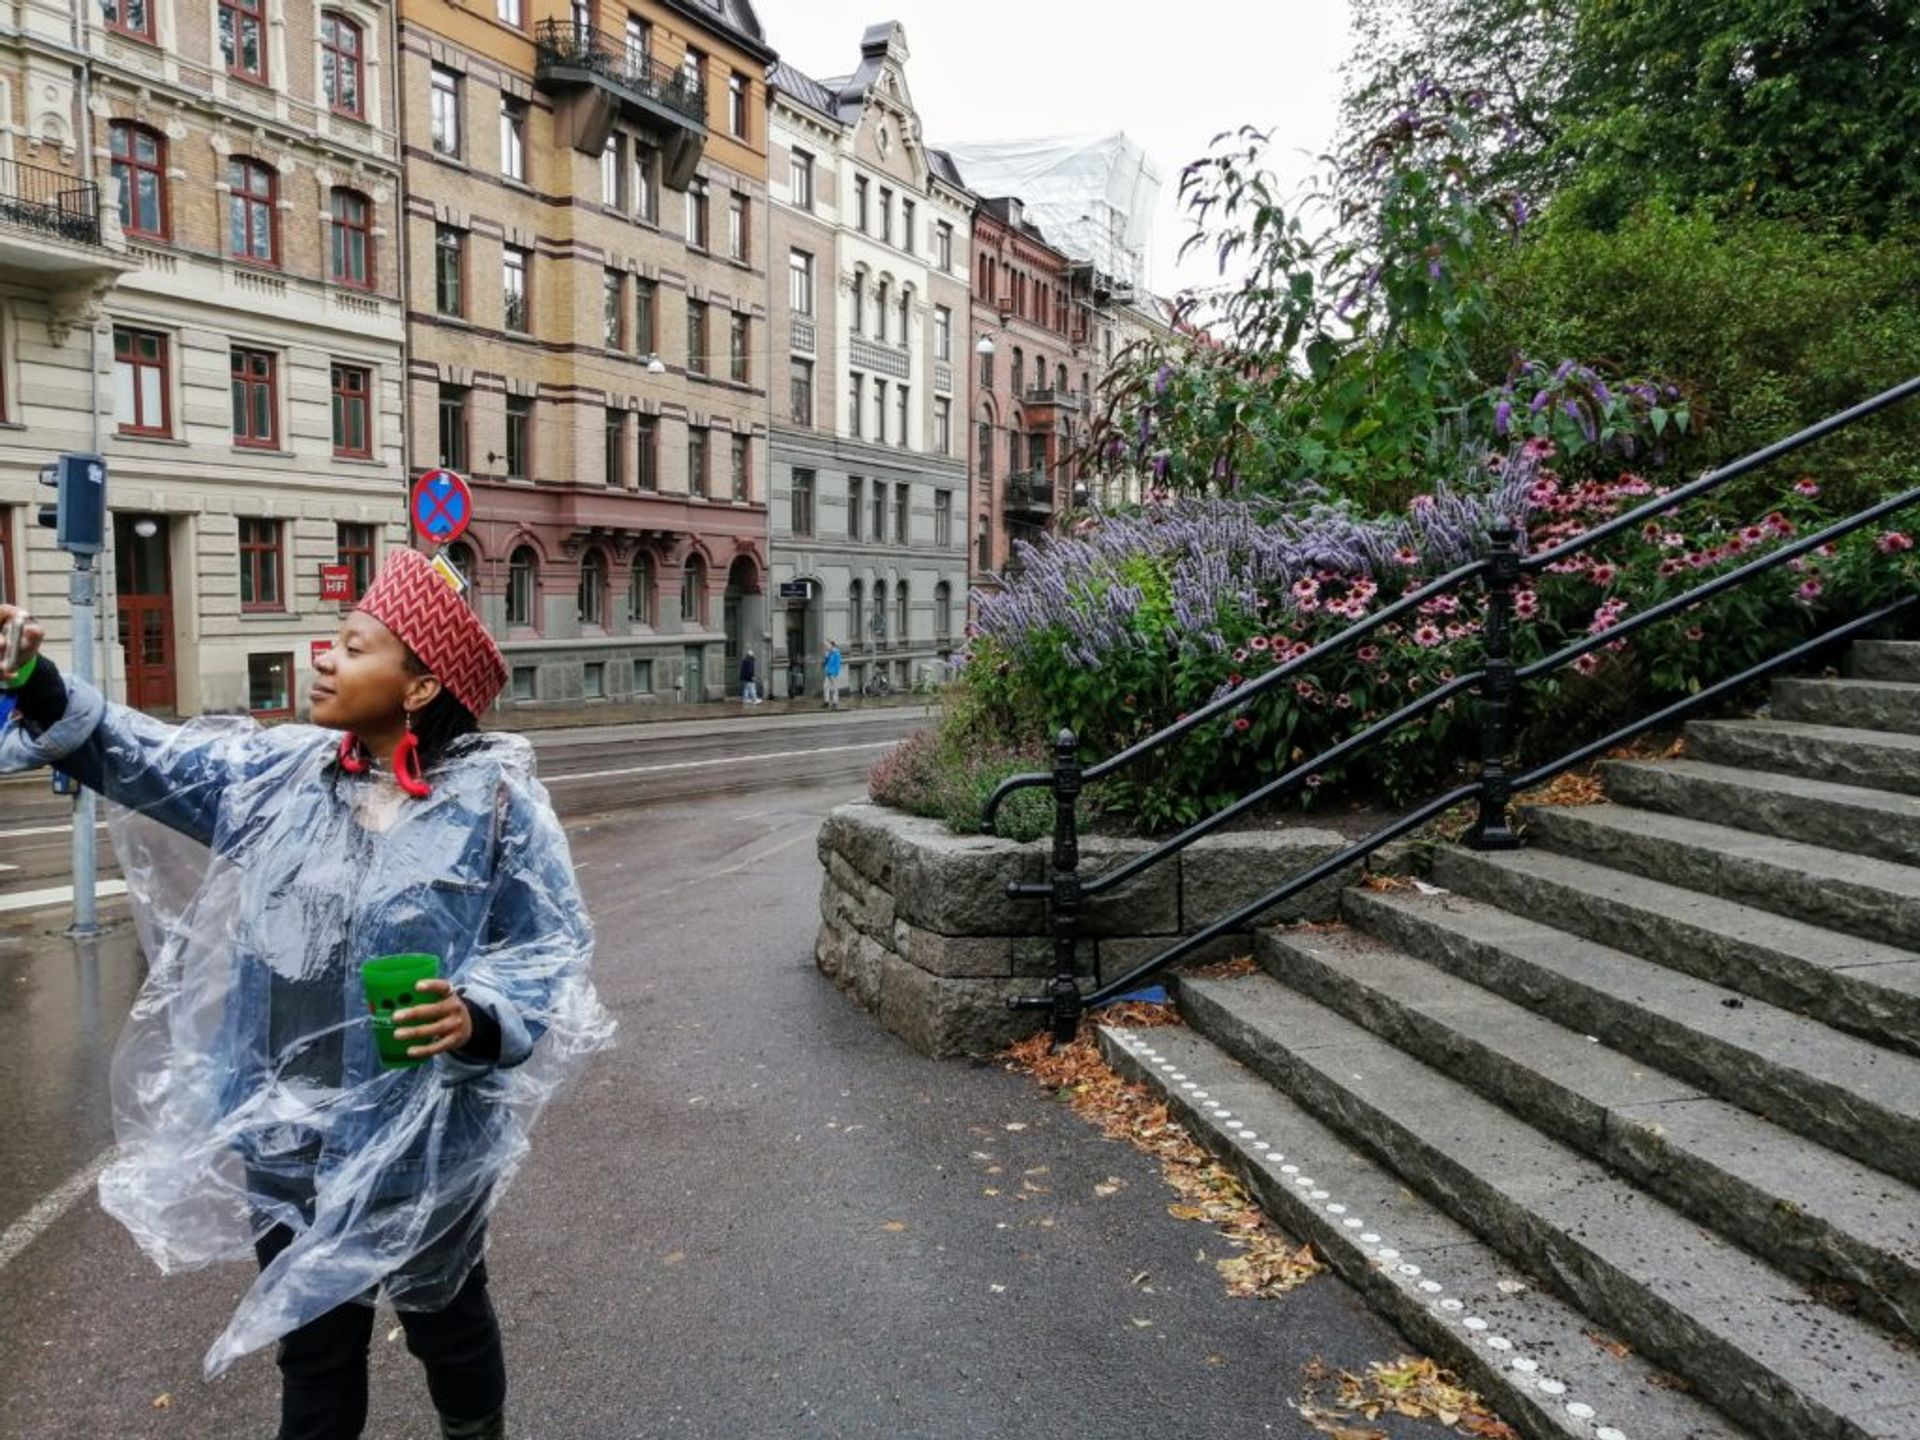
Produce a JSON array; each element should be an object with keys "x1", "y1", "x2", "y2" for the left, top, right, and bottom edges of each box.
[{"x1": 1179, "y1": 975, "x2": 1920, "y2": 1440}]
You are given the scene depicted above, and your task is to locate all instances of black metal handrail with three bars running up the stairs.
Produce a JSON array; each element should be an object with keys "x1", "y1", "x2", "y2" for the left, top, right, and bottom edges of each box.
[{"x1": 983, "y1": 376, "x2": 1920, "y2": 1043}]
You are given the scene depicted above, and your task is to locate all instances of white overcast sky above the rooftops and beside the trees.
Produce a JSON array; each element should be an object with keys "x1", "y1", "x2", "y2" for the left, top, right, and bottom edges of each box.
[{"x1": 758, "y1": 0, "x2": 1350, "y2": 294}]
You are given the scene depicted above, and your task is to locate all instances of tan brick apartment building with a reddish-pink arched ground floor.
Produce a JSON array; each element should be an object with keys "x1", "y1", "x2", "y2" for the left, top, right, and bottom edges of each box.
[{"x1": 397, "y1": 0, "x2": 774, "y2": 705}]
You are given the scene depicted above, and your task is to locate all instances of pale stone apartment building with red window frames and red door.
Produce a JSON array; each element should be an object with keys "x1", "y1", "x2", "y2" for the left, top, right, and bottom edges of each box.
[{"x1": 0, "y1": 0, "x2": 403, "y2": 716}]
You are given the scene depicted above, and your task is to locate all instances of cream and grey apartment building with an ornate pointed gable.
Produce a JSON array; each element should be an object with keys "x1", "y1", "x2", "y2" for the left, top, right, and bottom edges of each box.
[{"x1": 770, "y1": 23, "x2": 973, "y2": 695}]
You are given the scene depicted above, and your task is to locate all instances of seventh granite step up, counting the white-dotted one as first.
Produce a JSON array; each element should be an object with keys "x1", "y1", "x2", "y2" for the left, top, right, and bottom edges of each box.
[{"x1": 1605, "y1": 760, "x2": 1920, "y2": 866}]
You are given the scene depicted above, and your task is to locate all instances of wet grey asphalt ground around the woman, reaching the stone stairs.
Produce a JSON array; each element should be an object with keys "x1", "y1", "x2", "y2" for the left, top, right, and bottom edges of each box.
[{"x1": 0, "y1": 781, "x2": 1438, "y2": 1440}]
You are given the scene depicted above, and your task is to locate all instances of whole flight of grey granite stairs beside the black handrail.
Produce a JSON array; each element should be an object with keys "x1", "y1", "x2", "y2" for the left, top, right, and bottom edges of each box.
[{"x1": 1102, "y1": 641, "x2": 1920, "y2": 1440}]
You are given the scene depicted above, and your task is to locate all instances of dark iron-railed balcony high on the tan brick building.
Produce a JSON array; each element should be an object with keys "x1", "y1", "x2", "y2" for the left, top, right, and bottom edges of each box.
[{"x1": 534, "y1": 19, "x2": 707, "y2": 178}]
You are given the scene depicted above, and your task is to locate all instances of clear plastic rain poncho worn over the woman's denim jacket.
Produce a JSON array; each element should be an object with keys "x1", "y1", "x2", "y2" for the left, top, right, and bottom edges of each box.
[{"x1": 0, "y1": 680, "x2": 612, "y2": 1377}]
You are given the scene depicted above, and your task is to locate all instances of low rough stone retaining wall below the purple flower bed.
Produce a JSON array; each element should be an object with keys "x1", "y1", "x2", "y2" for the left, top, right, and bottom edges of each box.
[{"x1": 814, "y1": 803, "x2": 1346, "y2": 1056}]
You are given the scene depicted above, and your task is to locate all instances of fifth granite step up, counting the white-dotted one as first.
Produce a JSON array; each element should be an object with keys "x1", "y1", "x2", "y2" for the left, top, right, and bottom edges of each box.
[{"x1": 1434, "y1": 847, "x2": 1920, "y2": 1054}]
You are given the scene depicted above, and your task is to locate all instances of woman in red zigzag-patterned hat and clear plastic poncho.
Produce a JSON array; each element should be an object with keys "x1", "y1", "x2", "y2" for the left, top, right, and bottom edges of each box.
[{"x1": 0, "y1": 549, "x2": 612, "y2": 1440}]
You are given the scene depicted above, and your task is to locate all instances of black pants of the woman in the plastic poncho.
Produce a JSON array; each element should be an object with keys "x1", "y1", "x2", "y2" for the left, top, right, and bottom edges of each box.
[{"x1": 253, "y1": 1225, "x2": 507, "y2": 1440}]
